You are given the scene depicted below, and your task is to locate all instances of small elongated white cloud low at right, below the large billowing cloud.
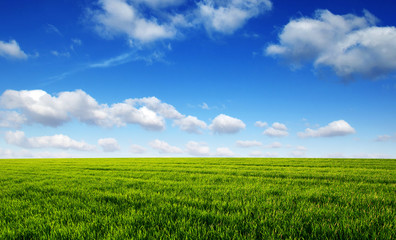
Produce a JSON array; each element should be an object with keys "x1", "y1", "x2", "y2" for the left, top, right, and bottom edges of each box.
[{"x1": 297, "y1": 120, "x2": 356, "y2": 138}]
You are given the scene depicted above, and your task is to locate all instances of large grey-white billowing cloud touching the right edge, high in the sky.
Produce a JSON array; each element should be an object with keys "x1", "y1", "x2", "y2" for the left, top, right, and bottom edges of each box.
[{"x1": 265, "y1": 10, "x2": 396, "y2": 79}]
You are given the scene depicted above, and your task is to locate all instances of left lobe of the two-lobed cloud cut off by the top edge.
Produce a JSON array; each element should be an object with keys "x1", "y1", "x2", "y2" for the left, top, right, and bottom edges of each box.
[{"x1": 92, "y1": 0, "x2": 176, "y2": 42}]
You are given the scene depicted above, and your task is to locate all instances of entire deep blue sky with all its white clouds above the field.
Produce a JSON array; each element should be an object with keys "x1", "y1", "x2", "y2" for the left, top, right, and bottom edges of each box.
[{"x1": 0, "y1": 0, "x2": 396, "y2": 158}]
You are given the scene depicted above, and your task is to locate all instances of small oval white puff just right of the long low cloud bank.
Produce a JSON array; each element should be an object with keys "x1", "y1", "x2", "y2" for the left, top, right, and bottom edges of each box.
[{"x1": 209, "y1": 114, "x2": 246, "y2": 134}]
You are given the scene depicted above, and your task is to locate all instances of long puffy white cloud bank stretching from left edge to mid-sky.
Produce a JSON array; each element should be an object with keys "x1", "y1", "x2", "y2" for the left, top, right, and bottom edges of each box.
[{"x1": 0, "y1": 90, "x2": 206, "y2": 132}]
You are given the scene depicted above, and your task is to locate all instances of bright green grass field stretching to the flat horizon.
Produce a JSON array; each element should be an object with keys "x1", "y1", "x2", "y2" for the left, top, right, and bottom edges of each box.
[{"x1": 0, "y1": 158, "x2": 396, "y2": 239}]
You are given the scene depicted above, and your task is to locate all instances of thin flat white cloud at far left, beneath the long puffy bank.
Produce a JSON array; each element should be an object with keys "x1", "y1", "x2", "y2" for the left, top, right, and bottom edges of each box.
[{"x1": 4, "y1": 131, "x2": 96, "y2": 151}]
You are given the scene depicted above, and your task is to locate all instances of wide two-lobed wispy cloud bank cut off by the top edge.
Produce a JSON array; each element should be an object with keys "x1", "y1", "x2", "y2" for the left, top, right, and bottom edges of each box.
[{"x1": 89, "y1": 0, "x2": 272, "y2": 43}]
